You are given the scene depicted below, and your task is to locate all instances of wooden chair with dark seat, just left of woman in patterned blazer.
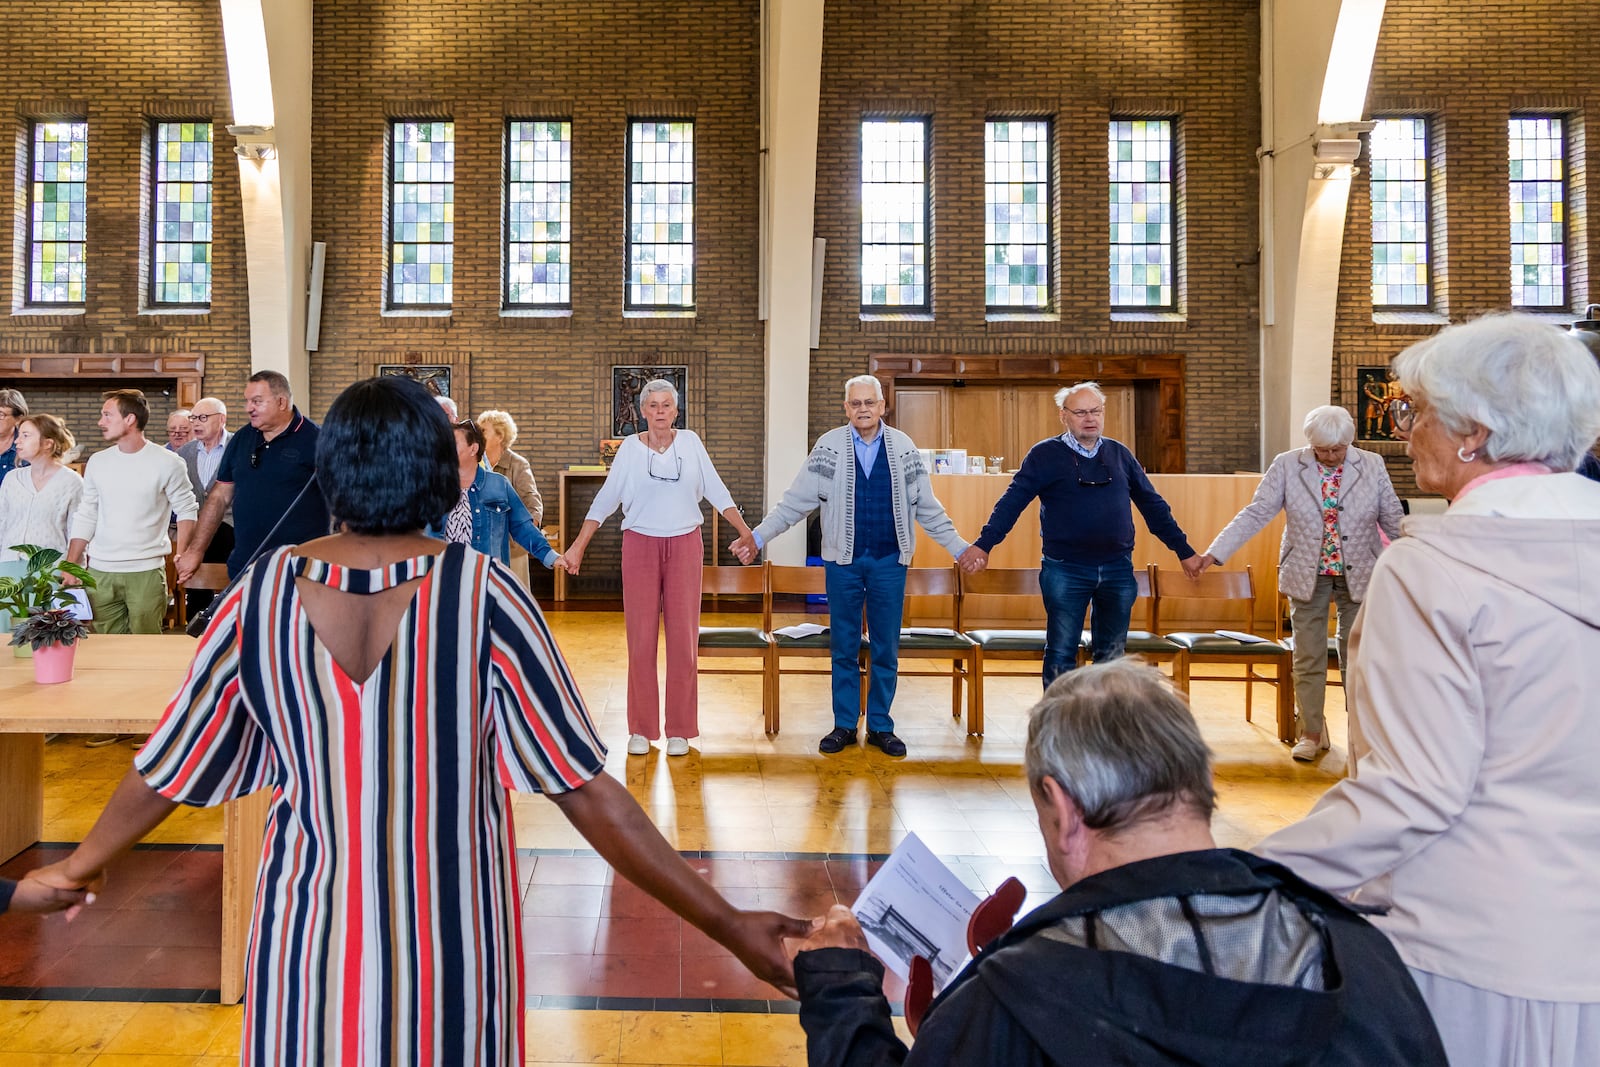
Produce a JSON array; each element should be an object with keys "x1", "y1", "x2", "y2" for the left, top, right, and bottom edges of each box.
[{"x1": 1152, "y1": 566, "x2": 1294, "y2": 744}]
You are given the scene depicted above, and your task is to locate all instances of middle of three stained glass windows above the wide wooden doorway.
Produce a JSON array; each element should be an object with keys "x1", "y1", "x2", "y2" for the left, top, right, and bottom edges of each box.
[{"x1": 984, "y1": 118, "x2": 1050, "y2": 310}]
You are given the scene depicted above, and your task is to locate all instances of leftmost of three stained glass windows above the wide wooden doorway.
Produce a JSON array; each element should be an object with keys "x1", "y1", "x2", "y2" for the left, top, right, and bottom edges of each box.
[{"x1": 861, "y1": 118, "x2": 928, "y2": 310}]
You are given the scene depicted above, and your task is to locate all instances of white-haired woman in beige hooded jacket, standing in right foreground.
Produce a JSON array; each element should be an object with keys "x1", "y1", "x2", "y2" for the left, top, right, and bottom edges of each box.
[{"x1": 1258, "y1": 315, "x2": 1600, "y2": 1067}]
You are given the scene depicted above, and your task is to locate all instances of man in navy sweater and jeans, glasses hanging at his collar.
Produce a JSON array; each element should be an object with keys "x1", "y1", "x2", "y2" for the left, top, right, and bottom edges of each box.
[{"x1": 973, "y1": 382, "x2": 1200, "y2": 688}]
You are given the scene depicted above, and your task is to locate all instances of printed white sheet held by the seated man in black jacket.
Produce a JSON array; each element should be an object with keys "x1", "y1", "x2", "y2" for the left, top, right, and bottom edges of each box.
[{"x1": 850, "y1": 833, "x2": 978, "y2": 992}]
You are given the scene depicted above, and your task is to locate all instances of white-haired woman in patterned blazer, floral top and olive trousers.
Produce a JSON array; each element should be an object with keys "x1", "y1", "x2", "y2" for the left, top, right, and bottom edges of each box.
[{"x1": 1200, "y1": 405, "x2": 1402, "y2": 761}]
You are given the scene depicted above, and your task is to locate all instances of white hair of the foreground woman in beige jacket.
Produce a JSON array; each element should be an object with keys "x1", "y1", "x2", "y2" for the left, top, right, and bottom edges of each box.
[{"x1": 1394, "y1": 312, "x2": 1600, "y2": 470}]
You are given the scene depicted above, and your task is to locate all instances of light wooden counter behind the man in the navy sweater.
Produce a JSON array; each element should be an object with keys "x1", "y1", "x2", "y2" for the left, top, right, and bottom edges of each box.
[{"x1": 907, "y1": 474, "x2": 1283, "y2": 633}]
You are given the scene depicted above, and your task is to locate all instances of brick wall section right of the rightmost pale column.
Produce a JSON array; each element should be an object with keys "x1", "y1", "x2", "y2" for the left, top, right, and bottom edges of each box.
[{"x1": 1333, "y1": 0, "x2": 1600, "y2": 496}]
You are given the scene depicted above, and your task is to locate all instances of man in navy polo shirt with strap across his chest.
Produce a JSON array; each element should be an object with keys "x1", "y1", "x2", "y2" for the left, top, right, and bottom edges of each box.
[{"x1": 178, "y1": 371, "x2": 328, "y2": 582}]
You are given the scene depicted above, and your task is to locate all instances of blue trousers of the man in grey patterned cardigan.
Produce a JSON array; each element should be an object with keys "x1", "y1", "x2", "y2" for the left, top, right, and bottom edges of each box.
[{"x1": 822, "y1": 555, "x2": 906, "y2": 733}]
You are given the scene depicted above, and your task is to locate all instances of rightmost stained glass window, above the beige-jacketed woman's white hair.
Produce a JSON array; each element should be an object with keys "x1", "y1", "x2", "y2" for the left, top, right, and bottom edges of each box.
[{"x1": 1509, "y1": 115, "x2": 1566, "y2": 307}]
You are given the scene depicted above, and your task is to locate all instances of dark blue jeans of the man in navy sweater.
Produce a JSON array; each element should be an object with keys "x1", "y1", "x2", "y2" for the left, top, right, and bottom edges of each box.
[{"x1": 1038, "y1": 555, "x2": 1139, "y2": 686}]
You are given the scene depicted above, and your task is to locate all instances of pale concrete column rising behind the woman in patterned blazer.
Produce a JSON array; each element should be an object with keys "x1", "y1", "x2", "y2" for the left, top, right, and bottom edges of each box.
[{"x1": 1261, "y1": 0, "x2": 1384, "y2": 462}]
